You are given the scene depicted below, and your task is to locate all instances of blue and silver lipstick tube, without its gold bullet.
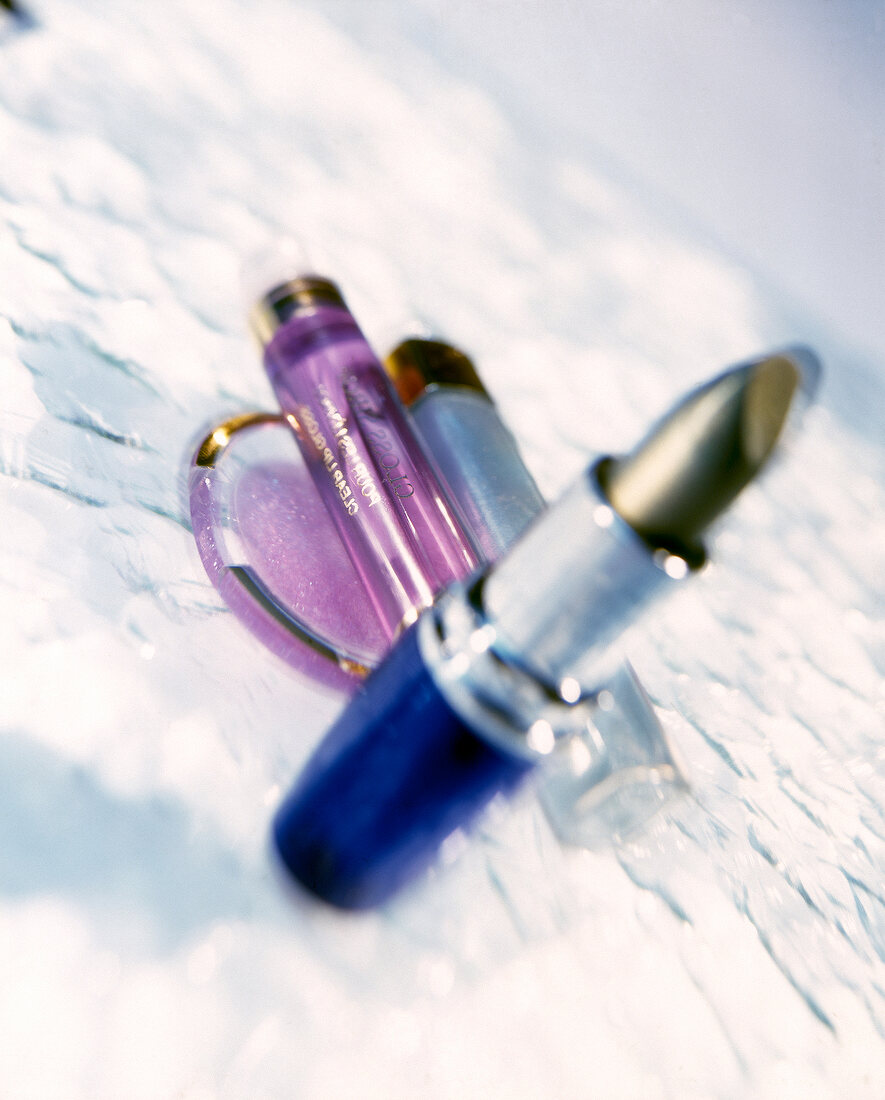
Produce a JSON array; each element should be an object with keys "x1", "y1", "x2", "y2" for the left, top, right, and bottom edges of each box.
[{"x1": 274, "y1": 459, "x2": 704, "y2": 909}]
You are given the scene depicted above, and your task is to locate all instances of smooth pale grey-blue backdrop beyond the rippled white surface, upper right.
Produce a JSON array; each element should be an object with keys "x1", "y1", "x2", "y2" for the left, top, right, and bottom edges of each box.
[{"x1": 323, "y1": 0, "x2": 885, "y2": 360}]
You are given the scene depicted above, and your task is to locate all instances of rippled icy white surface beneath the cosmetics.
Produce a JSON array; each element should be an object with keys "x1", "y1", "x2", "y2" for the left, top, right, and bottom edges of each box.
[{"x1": 0, "y1": 0, "x2": 885, "y2": 1100}]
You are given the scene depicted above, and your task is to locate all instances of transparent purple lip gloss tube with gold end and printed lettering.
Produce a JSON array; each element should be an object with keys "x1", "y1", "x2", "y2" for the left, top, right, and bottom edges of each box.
[{"x1": 251, "y1": 274, "x2": 477, "y2": 638}]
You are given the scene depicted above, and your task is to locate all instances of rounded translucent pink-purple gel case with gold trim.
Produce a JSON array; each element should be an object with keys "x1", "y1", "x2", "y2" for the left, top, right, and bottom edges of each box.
[{"x1": 190, "y1": 419, "x2": 389, "y2": 691}]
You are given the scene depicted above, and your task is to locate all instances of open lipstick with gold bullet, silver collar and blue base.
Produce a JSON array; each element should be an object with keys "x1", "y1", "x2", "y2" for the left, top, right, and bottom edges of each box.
[{"x1": 273, "y1": 348, "x2": 820, "y2": 909}]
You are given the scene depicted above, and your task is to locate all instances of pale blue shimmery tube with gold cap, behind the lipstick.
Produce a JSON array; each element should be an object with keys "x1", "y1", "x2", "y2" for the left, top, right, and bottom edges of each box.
[{"x1": 385, "y1": 337, "x2": 544, "y2": 562}]
